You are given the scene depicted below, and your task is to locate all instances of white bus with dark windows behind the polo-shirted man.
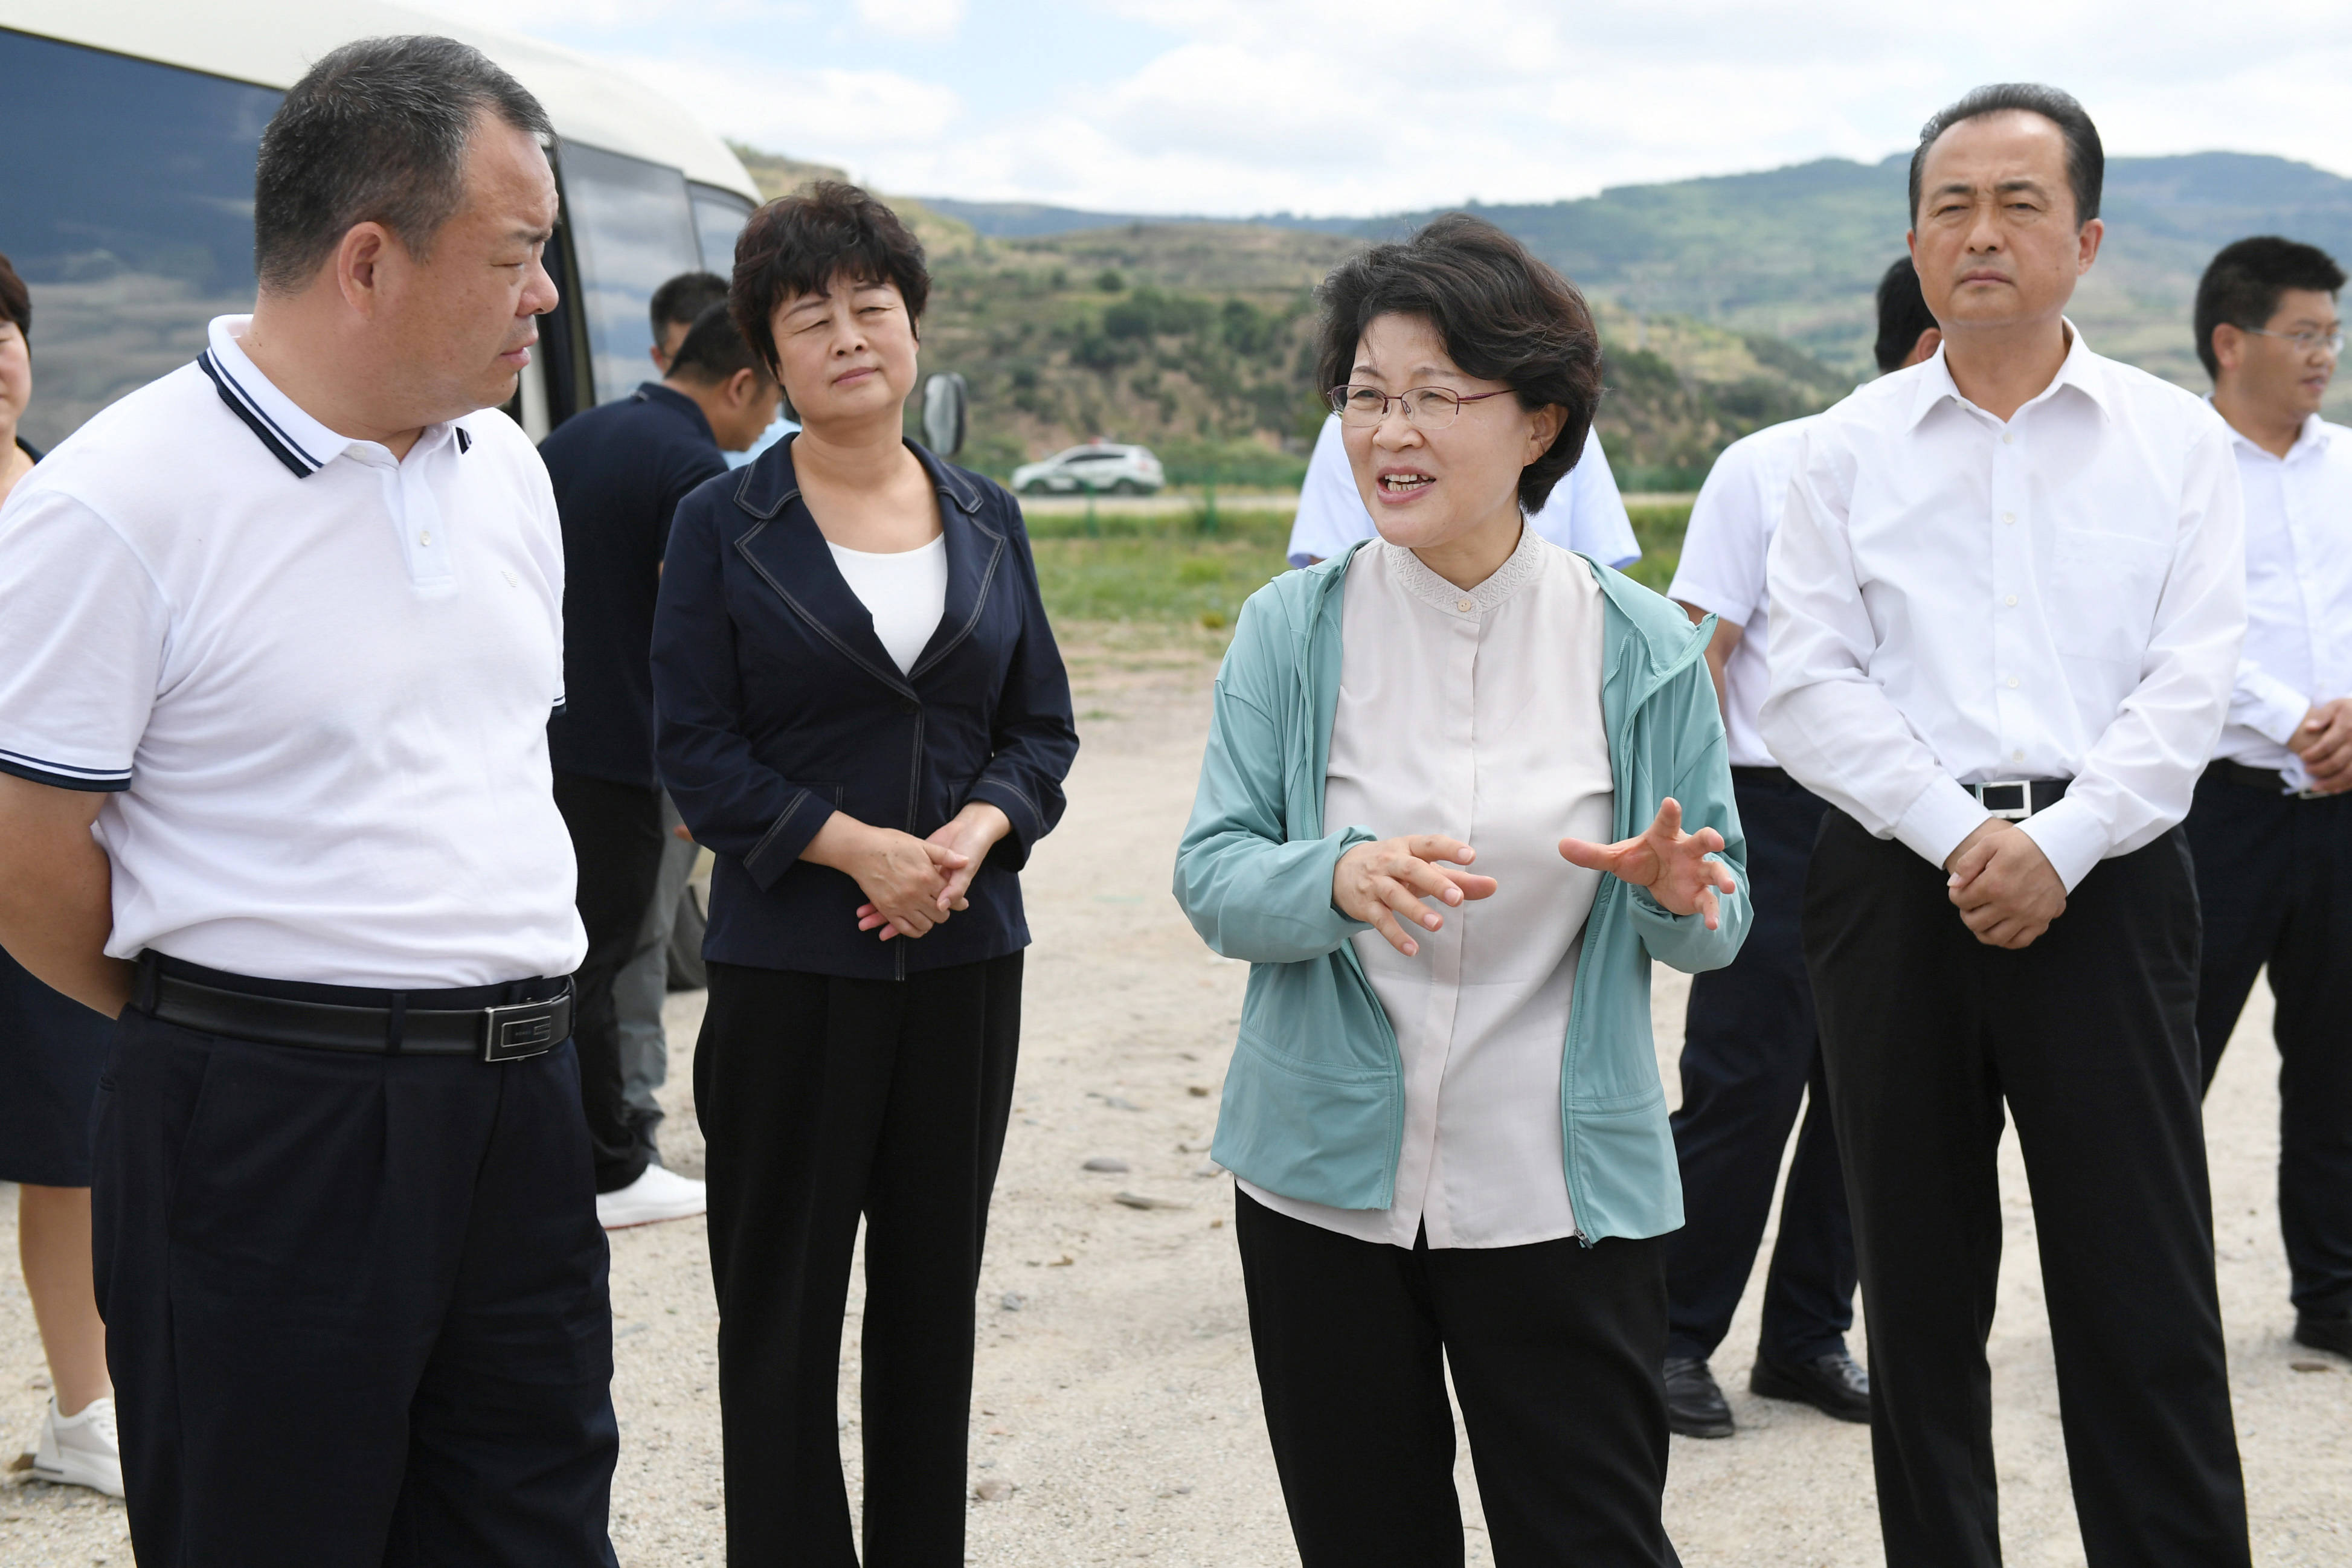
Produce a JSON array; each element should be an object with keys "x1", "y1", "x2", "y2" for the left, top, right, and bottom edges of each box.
[{"x1": 0, "y1": 0, "x2": 760, "y2": 449}]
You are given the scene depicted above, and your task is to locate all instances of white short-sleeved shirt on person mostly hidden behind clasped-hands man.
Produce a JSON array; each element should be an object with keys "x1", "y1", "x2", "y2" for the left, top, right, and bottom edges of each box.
[{"x1": 1665, "y1": 414, "x2": 1813, "y2": 769}]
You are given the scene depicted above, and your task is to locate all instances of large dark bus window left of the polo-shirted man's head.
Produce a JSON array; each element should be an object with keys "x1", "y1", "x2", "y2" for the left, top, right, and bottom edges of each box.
[{"x1": 0, "y1": 28, "x2": 282, "y2": 446}]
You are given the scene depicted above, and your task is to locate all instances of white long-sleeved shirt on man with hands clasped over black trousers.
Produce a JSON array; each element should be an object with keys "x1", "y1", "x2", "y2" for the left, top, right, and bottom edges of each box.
[{"x1": 1762, "y1": 324, "x2": 2246, "y2": 888}]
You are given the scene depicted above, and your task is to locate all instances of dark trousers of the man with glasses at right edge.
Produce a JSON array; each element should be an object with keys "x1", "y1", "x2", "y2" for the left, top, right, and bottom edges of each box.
[{"x1": 2185, "y1": 771, "x2": 2352, "y2": 1317}]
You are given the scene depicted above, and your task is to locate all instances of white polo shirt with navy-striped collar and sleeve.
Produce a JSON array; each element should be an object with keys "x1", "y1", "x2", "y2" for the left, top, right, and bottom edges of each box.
[{"x1": 0, "y1": 317, "x2": 586, "y2": 990}]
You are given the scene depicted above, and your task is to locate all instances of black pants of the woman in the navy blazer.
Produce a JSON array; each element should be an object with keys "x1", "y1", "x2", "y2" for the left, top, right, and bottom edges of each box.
[{"x1": 694, "y1": 952, "x2": 1021, "y2": 1568}]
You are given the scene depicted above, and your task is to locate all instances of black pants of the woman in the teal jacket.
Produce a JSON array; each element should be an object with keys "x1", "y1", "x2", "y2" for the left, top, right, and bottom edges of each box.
[{"x1": 1235, "y1": 1192, "x2": 1679, "y2": 1568}]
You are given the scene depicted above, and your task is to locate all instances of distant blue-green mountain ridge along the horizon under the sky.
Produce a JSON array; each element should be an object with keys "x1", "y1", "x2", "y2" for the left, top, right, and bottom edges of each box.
[{"x1": 924, "y1": 153, "x2": 2352, "y2": 388}]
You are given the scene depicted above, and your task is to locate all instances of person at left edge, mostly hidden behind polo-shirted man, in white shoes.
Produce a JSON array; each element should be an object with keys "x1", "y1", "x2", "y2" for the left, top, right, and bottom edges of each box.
[{"x1": 0, "y1": 256, "x2": 122, "y2": 1497}]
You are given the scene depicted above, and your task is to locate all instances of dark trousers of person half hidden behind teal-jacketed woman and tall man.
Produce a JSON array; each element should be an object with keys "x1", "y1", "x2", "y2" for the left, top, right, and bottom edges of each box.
[{"x1": 1665, "y1": 769, "x2": 1853, "y2": 1366}]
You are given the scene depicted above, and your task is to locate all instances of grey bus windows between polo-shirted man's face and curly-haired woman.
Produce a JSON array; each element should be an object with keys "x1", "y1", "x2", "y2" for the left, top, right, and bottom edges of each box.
[{"x1": 557, "y1": 141, "x2": 701, "y2": 402}]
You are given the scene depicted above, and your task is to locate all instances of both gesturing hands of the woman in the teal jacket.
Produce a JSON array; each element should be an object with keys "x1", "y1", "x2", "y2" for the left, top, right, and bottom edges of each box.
[{"x1": 1331, "y1": 797, "x2": 1738, "y2": 957}]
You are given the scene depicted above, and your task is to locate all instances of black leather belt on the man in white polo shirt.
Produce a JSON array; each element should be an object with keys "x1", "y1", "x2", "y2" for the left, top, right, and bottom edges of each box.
[{"x1": 132, "y1": 959, "x2": 571, "y2": 1062}]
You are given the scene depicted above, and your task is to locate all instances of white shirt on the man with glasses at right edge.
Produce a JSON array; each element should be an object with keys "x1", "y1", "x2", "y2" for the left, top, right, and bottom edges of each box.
[{"x1": 2213, "y1": 414, "x2": 2352, "y2": 790}]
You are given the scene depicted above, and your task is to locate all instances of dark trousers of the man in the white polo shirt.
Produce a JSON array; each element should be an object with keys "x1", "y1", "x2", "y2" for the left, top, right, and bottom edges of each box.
[{"x1": 92, "y1": 992, "x2": 621, "y2": 1568}]
